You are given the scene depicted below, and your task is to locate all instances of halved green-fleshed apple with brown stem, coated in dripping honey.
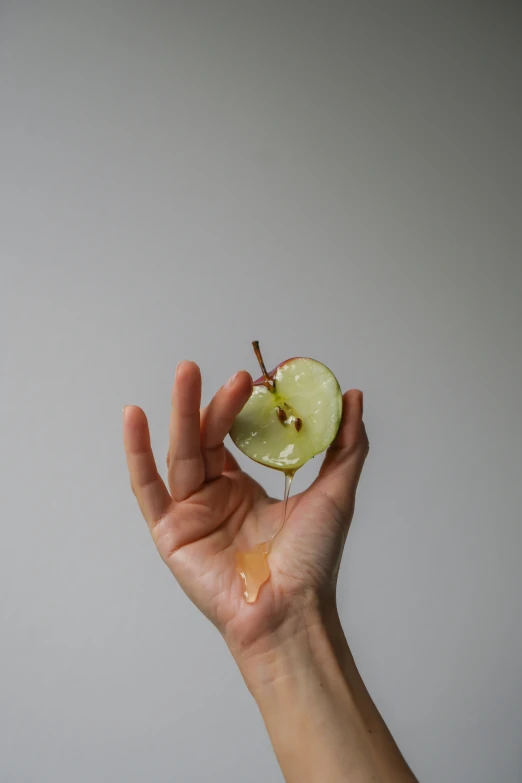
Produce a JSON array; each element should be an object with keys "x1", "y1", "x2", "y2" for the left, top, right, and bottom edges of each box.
[{"x1": 230, "y1": 341, "x2": 343, "y2": 473}]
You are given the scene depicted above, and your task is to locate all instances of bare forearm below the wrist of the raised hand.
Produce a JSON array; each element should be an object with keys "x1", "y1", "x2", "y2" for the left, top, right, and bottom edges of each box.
[{"x1": 231, "y1": 611, "x2": 415, "y2": 783}]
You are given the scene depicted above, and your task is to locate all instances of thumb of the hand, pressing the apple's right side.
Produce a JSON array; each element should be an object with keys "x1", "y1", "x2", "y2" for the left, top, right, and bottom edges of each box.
[{"x1": 309, "y1": 389, "x2": 370, "y2": 525}]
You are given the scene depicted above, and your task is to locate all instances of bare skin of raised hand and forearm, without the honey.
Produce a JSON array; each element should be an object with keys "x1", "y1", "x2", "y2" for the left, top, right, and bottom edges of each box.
[{"x1": 124, "y1": 362, "x2": 415, "y2": 783}]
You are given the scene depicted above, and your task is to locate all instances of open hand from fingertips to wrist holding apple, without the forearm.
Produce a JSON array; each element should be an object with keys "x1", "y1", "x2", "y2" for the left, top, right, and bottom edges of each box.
[{"x1": 124, "y1": 362, "x2": 368, "y2": 651}]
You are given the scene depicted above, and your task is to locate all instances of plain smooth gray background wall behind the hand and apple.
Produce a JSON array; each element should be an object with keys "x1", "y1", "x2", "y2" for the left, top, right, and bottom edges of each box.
[{"x1": 0, "y1": 0, "x2": 522, "y2": 783}]
